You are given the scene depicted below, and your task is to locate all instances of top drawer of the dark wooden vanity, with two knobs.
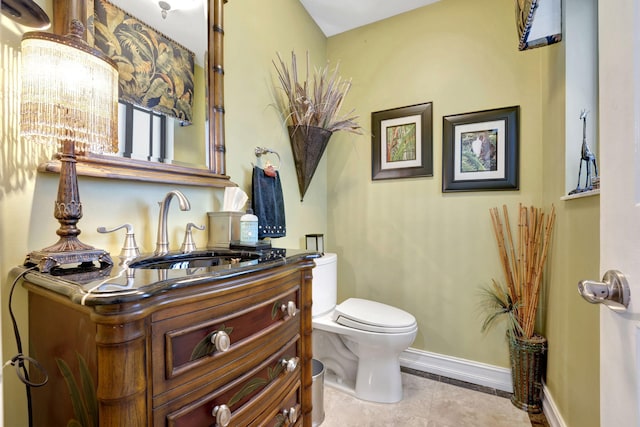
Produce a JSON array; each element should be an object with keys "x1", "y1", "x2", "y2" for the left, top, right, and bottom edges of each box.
[{"x1": 151, "y1": 286, "x2": 300, "y2": 407}]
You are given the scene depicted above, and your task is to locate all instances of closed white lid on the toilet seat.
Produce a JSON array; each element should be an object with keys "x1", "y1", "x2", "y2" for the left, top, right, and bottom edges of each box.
[{"x1": 333, "y1": 298, "x2": 416, "y2": 334}]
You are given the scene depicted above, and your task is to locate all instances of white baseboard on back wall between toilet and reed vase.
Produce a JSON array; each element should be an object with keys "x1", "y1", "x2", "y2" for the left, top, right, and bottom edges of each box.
[{"x1": 400, "y1": 348, "x2": 513, "y2": 393}]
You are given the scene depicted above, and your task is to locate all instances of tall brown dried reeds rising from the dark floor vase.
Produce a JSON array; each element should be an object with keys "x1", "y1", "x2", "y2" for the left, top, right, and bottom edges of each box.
[{"x1": 482, "y1": 205, "x2": 556, "y2": 339}]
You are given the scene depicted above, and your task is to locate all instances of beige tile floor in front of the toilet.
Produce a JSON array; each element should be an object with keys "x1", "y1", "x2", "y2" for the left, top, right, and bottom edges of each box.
[{"x1": 321, "y1": 372, "x2": 548, "y2": 427}]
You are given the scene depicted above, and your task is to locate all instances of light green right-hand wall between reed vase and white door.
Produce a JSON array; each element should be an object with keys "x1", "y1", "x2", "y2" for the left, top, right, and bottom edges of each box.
[{"x1": 540, "y1": 35, "x2": 600, "y2": 427}]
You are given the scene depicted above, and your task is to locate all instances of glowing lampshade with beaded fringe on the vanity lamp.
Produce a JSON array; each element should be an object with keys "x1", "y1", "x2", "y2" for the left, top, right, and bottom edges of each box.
[{"x1": 20, "y1": 23, "x2": 118, "y2": 153}]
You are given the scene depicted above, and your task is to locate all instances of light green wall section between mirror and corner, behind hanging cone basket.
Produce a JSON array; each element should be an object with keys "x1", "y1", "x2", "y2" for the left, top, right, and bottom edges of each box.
[{"x1": 225, "y1": 0, "x2": 327, "y2": 248}]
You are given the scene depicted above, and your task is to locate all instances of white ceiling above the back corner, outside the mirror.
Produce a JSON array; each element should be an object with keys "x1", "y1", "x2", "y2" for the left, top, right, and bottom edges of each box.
[{"x1": 300, "y1": 0, "x2": 439, "y2": 37}]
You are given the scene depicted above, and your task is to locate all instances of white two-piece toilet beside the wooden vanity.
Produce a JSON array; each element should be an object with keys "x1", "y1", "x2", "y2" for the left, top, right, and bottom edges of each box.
[{"x1": 312, "y1": 253, "x2": 418, "y2": 403}]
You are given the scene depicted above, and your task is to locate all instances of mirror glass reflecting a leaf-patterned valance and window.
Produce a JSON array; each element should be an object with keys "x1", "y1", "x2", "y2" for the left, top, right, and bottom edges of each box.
[{"x1": 102, "y1": 0, "x2": 207, "y2": 168}]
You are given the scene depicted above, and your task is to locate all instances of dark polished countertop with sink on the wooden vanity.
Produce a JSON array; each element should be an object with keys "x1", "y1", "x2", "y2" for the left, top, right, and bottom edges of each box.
[{"x1": 15, "y1": 248, "x2": 321, "y2": 306}]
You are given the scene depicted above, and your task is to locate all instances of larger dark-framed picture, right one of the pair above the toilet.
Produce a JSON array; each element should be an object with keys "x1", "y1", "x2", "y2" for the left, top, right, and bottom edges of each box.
[{"x1": 442, "y1": 106, "x2": 520, "y2": 192}]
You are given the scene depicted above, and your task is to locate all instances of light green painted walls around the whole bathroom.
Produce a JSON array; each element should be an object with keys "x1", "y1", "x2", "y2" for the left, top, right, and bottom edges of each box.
[{"x1": 0, "y1": 0, "x2": 599, "y2": 427}]
